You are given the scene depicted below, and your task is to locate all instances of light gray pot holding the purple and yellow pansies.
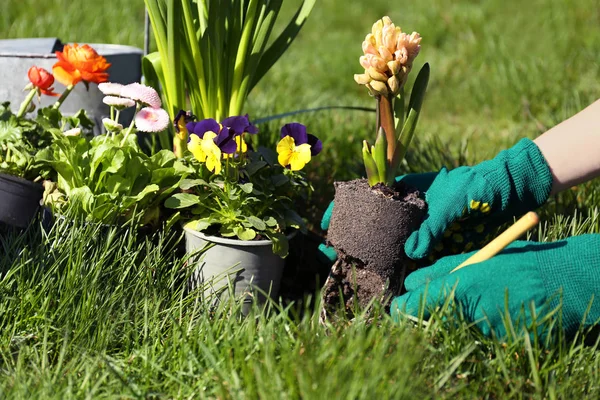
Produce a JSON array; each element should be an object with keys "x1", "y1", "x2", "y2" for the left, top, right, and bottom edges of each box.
[{"x1": 185, "y1": 228, "x2": 292, "y2": 314}]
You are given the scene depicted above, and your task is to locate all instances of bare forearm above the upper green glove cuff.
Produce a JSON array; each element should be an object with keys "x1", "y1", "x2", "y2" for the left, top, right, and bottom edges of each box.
[{"x1": 534, "y1": 100, "x2": 600, "y2": 194}]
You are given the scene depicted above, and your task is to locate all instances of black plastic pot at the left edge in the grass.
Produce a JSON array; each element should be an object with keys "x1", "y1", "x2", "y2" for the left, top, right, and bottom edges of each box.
[{"x1": 0, "y1": 174, "x2": 44, "y2": 228}]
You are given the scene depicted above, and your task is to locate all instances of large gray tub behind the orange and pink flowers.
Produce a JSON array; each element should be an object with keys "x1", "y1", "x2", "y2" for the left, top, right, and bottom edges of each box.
[{"x1": 0, "y1": 38, "x2": 142, "y2": 134}]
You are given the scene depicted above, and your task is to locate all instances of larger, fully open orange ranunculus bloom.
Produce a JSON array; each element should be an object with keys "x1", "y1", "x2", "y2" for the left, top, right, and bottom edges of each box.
[{"x1": 52, "y1": 43, "x2": 110, "y2": 86}]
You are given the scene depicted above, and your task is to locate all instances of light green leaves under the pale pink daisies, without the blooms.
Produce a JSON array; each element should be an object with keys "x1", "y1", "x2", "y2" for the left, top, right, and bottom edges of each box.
[{"x1": 36, "y1": 133, "x2": 189, "y2": 225}]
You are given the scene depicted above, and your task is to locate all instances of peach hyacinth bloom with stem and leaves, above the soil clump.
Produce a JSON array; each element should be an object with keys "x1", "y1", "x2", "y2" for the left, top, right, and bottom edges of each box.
[{"x1": 354, "y1": 16, "x2": 429, "y2": 187}]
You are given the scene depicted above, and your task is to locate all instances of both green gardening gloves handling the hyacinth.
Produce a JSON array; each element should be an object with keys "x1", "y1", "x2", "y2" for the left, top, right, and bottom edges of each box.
[{"x1": 320, "y1": 139, "x2": 600, "y2": 338}]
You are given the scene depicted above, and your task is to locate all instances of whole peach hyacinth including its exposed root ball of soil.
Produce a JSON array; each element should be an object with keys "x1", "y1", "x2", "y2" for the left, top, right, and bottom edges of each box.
[{"x1": 323, "y1": 17, "x2": 429, "y2": 312}]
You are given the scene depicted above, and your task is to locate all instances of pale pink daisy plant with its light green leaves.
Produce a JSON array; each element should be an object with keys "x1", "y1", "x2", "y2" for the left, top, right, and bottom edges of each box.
[{"x1": 36, "y1": 82, "x2": 189, "y2": 226}]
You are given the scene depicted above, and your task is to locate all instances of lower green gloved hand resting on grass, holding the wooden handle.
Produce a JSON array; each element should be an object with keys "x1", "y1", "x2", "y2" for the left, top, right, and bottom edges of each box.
[{"x1": 390, "y1": 234, "x2": 600, "y2": 337}]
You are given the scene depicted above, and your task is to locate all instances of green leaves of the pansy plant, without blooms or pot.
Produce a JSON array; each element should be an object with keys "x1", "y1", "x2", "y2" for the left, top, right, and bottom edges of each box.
[{"x1": 165, "y1": 147, "x2": 312, "y2": 257}]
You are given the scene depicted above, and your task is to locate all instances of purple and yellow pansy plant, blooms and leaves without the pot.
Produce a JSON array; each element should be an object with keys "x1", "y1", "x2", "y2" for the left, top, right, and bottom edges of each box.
[{"x1": 165, "y1": 112, "x2": 323, "y2": 257}]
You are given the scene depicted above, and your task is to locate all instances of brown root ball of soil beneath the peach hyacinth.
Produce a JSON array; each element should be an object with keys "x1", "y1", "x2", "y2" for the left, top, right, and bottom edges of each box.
[{"x1": 323, "y1": 179, "x2": 427, "y2": 315}]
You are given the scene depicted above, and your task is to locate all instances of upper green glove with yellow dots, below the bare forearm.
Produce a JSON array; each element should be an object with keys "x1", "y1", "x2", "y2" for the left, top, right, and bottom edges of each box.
[{"x1": 404, "y1": 139, "x2": 552, "y2": 261}]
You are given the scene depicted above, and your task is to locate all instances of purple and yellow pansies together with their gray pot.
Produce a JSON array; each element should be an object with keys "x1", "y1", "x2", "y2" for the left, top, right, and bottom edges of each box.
[{"x1": 165, "y1": 113, "x2": 322, "y2": 310}]
